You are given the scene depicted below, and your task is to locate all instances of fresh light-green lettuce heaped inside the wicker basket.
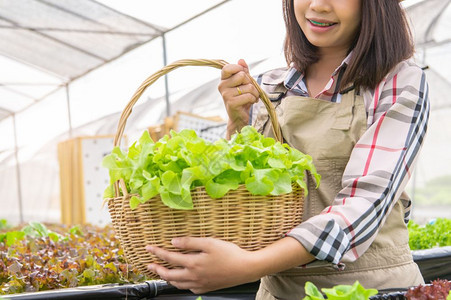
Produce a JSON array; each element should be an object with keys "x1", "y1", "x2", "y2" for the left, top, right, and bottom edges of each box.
[{"x1": 102, "y1": 126, "x2": 320, "y2": 209}]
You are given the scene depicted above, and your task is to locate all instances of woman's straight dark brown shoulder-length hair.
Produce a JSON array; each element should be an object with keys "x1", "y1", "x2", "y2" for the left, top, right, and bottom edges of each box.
[{"x1": 283, "y1": 0, "x2": 414, "y2": 90}]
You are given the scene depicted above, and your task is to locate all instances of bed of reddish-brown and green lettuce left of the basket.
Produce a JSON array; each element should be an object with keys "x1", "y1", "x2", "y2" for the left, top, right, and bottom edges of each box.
[{"x1": 0, "y1": 223, "x2": 146, "y2": 295}]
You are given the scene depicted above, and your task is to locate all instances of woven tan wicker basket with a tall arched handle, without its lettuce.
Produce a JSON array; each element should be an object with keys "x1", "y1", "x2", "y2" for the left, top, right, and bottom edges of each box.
[{"x1": 106, "y1": 60, "x2": 304, "y2": 277}]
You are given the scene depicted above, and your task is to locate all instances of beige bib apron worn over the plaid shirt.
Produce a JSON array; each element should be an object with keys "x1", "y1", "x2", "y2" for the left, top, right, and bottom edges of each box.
[{"x1": 254, "y1": 86, "x2": 424, "y2": 300}]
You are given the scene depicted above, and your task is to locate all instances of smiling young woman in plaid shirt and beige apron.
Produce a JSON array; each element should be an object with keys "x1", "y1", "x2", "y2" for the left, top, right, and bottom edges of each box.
[{"x1": 148, "y1": 0, "x2": 429, "y2": 299}]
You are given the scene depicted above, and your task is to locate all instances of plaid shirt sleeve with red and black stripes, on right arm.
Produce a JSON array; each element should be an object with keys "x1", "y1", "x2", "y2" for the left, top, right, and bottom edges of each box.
[{"x1": 287, "y1": 61, "x2": 429, "y2": 264}]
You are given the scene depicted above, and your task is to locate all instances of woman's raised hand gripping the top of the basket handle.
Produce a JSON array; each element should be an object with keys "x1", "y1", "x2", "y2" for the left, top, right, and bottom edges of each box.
[{"x1": 218, "y1": 59, "x2": 259, "y2": 138}]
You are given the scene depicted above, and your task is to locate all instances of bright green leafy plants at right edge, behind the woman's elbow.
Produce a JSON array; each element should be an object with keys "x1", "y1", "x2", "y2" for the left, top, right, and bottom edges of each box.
[{"x1": 407, "y1": 218, "x2": 451, "y2": 250}]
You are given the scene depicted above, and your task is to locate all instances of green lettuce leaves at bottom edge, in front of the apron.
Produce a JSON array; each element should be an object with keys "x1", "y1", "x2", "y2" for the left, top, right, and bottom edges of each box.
[{"x1": 303, "y1": 281, "x2": 378, "y2": 300}]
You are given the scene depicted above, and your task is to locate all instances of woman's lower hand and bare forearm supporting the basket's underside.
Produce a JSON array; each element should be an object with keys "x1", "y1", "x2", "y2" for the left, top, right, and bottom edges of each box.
[{"x1": 146, "y1": 237, "x2": 315, "y2": 294}]
